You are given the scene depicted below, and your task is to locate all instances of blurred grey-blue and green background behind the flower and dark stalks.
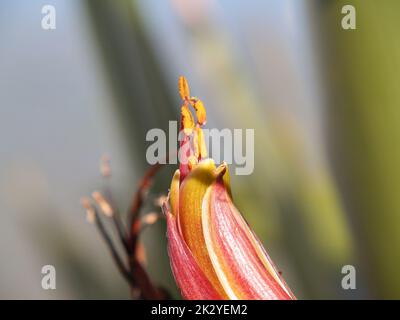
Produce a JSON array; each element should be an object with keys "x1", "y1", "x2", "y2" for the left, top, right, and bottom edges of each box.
[{"x1": 0, "y1": 0, "x2": 400, "y2": 299}]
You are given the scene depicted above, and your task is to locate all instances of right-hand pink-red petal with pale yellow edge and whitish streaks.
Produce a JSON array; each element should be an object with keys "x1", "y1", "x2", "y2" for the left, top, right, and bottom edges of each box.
[{"x1": 203, "y1": 181, "x2": 294, "y2": 300}]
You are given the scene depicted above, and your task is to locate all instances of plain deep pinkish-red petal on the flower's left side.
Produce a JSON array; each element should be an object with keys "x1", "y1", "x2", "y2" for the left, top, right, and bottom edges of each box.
[{"x1": 164, "y1": 208, "x2": 221, "y2": 300}]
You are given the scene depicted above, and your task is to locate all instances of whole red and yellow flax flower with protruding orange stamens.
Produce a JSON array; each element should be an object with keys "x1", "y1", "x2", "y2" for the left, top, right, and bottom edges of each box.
[{"x1": 163, "y1": 77, "x2": 295, "y2": 300}]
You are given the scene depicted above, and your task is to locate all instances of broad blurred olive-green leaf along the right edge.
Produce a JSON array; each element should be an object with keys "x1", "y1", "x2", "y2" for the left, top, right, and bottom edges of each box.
[{"x1": 314, "y1": 0, "x2": 400, "y2": 298}]
